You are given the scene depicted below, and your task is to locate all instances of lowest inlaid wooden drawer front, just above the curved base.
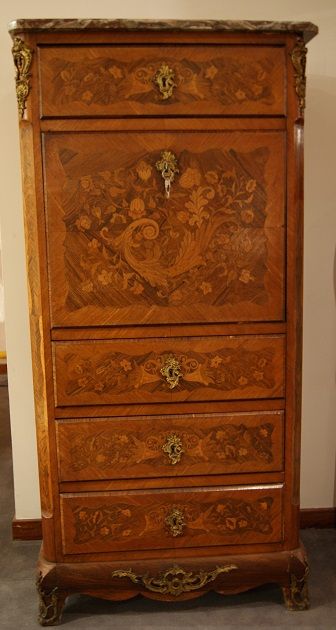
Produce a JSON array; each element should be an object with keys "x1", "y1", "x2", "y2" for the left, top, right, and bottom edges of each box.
[{"x1": 61, "y1": 486, "x2": 282, "y2": 554}]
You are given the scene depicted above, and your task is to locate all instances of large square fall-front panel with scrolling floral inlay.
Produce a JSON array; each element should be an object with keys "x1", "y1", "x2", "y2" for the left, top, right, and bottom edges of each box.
[{"x1": 44, "y1": 130, "x2": 285, "y2": 327}]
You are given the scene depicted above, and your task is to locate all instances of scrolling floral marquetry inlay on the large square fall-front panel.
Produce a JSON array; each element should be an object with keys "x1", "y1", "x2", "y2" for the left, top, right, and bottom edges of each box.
[{"x1": 61, "y1": 147, "x2": 269, "y2": 311}]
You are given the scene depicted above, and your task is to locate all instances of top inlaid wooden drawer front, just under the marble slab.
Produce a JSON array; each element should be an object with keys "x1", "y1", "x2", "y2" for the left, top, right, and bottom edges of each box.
[{"x1": 39, "y1": 45, "x2": 286, "y2": 117}]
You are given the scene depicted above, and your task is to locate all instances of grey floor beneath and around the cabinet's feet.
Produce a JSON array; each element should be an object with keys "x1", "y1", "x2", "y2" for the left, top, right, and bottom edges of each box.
[{"x1": 0, "y1": 387, "x2": 336, "y2": 630}]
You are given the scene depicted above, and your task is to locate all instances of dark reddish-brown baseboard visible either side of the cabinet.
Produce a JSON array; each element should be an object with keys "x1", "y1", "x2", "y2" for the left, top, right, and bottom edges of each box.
[{"x1": 12, "y1": 507, "x2": 336, "y2": 540}]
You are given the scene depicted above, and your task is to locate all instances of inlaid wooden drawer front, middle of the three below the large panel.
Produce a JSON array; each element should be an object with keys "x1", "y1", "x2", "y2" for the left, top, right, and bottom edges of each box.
[{"x1": 56, "y1": 411, "x2": 284, "y2": 481}]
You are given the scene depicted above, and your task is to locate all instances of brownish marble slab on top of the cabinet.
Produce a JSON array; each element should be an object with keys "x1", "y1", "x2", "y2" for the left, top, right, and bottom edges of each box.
[{"x1": 9, "y1": 19, "x2": 318, "y2": 42}]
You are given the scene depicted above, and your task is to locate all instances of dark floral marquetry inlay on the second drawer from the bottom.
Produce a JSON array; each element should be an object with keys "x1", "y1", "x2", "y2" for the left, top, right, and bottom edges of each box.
[{"x1": 70, "y1": 422, "x2": 274, "y2": 472}]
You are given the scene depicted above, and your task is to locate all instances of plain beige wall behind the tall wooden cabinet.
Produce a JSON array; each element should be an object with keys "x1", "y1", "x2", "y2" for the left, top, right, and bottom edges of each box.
[{"x1": 0, "y1": 0, "x2": 336, "y2": 518}]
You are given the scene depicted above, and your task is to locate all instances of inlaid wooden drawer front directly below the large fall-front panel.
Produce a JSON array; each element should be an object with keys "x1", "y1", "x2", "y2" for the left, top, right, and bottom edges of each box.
[{"x1": 54, "y1": 335, "x2": 284, "y2": 406}]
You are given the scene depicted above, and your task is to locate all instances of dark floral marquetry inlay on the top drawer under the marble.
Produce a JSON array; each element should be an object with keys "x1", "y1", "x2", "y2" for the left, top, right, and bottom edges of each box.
[{"x1": 50, "y1": 55, "x2": 274, "y2": 106}]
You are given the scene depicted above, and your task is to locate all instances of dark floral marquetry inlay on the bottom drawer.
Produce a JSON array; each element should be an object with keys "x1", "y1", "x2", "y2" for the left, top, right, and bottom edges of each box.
[{"x1": 72, "y1": 495, "x2": 274, "y2": 545}]
